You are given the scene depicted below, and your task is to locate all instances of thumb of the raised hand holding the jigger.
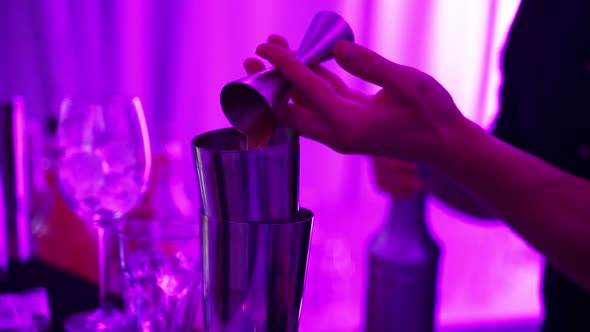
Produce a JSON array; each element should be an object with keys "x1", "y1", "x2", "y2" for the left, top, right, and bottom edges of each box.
[{"x1": 334, "y1": 41, "x2": 426, "y2": 95}]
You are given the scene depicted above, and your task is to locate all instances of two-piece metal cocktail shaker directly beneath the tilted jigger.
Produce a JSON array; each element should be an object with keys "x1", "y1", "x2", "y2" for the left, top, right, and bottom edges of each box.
[{"x1": 192, "y1": 128, "x2": 313, "y2": 332}]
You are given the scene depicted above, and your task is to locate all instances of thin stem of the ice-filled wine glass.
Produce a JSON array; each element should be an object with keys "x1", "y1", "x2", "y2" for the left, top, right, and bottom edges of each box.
[{"x1": 98, "y1": 223, "x2": 112, "y2": 309}]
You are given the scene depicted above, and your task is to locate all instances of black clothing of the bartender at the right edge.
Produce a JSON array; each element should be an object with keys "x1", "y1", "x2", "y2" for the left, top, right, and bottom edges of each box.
[{"x1": 494, "y1": 0, "x2": 590, "y2": 332}]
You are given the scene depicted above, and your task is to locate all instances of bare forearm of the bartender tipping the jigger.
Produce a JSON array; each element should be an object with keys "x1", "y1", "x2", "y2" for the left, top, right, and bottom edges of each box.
[{"x1": 432, "y1": 118, "x2": 590, "y2": 289}]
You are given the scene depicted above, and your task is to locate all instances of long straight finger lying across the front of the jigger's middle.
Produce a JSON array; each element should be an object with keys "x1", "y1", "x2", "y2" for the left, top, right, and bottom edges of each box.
[{"x1": 256, "y1": 43, "x2": 342, "y2": 115}]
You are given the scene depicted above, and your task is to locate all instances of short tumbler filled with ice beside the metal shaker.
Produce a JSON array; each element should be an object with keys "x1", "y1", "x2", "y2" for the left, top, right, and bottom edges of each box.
[{"x1": 119, "y1": 219, "x2": 202, "y2": 332}]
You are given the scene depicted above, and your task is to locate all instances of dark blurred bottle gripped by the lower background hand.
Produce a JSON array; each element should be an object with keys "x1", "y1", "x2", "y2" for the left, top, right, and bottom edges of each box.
[{"x1": 366, "y1": 193, "x2": 440, "y2": 332}]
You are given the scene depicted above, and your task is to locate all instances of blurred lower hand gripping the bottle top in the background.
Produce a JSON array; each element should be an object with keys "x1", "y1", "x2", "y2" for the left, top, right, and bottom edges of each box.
[{"x1": 371, "y1": 157, "x2": 426, "y2": 199}]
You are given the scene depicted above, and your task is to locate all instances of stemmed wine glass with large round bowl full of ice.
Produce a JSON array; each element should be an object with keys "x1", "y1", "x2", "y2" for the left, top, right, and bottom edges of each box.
[{"x1": 57, "y1": 97, "x2": 151, "y2": 332}]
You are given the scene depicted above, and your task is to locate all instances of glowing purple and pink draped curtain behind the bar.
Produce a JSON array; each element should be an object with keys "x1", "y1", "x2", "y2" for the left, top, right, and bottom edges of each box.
[{"x1": 0, "y1": 0, "x2": 541, "y2": 331}]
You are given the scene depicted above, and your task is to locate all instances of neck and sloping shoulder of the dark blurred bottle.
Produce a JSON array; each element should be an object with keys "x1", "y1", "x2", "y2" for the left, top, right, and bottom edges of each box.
[{"x1": 385, "y1": 194, "x2": 426, "y2": 234}]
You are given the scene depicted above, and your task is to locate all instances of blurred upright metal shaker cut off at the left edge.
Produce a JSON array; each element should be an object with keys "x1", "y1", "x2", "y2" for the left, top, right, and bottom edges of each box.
[{"x1": 0, "y1": 97, "x2": 31, "y2": 278}]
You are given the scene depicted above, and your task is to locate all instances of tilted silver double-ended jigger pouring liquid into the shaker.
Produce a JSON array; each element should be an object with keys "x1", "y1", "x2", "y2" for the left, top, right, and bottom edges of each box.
[{"x1": 221, "y1": 11, "x2": 354, "y2": 136}]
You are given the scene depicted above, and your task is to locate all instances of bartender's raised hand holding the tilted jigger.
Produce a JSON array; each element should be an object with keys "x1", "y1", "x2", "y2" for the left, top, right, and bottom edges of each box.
[{"x1": 252, "y1": 36, "x2": 466, "y2": 161}]
